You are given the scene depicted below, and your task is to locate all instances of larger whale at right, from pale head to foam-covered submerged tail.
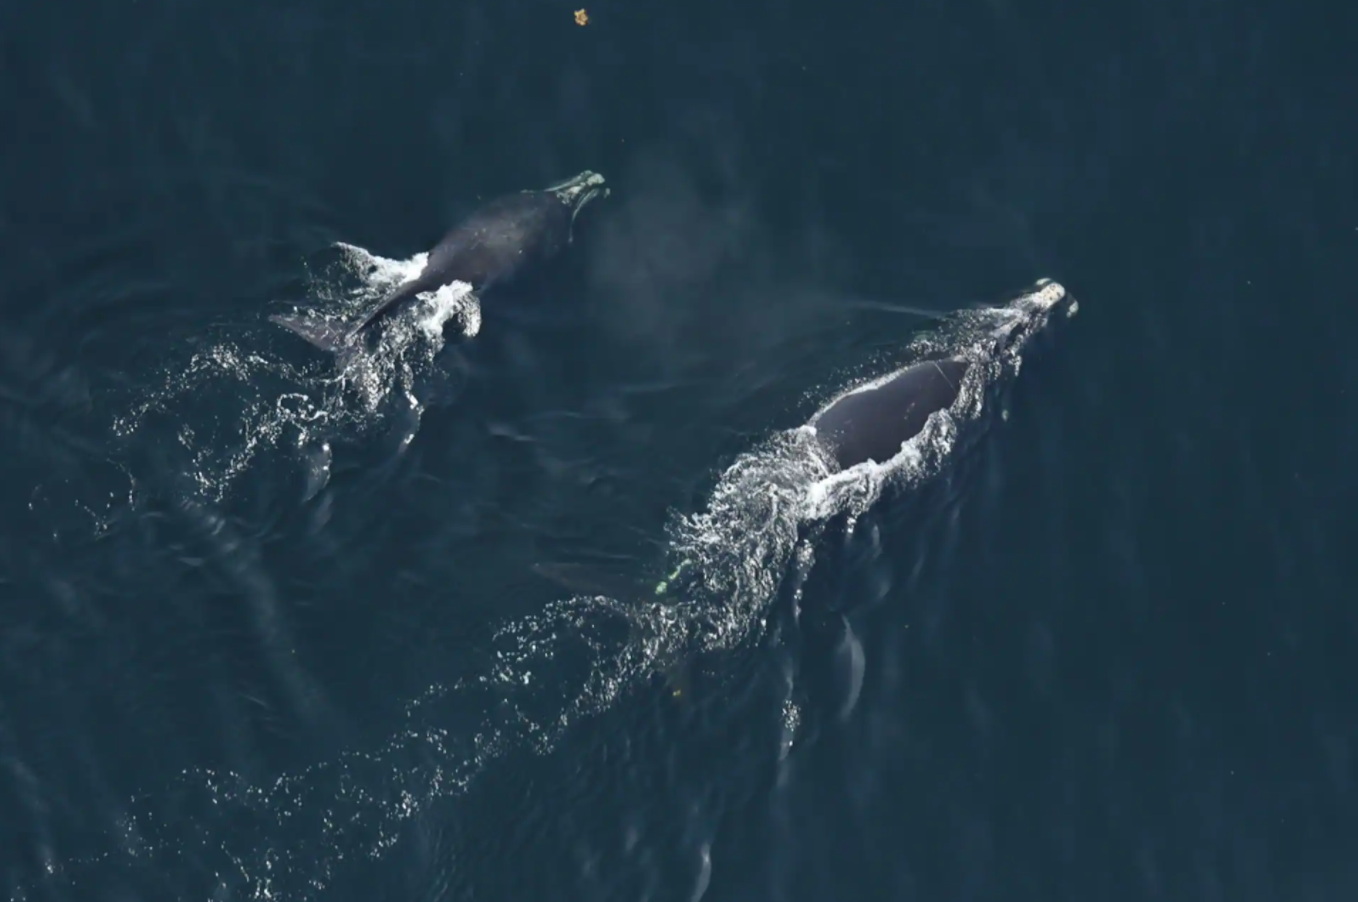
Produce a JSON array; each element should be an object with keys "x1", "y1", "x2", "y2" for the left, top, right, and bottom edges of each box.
[{"x1": 532, "y1": 280, "x2": 1077, "y2": 710}]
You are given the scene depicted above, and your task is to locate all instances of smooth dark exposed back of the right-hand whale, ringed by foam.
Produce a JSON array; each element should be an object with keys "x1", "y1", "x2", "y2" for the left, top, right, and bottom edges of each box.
[{"x1": 811, "y1": 359, "x2": 970, "y2": 470}]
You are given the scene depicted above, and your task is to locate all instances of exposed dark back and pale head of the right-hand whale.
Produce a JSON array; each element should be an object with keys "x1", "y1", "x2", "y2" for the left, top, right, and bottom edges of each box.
[{"x1": 808, "y1": 280, "x2": 1066, "y2": 470}]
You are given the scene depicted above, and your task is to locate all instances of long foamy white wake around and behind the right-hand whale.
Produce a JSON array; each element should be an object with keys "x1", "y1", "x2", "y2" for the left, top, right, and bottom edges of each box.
[{"x1": 21, "y1": 282, "x2": 1059, "y2": 899}]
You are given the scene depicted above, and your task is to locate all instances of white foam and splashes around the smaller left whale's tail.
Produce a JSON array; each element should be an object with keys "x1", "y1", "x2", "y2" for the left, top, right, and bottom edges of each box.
[{"x1": 113, "y1": 243, "x2": 481, "y2": 501}]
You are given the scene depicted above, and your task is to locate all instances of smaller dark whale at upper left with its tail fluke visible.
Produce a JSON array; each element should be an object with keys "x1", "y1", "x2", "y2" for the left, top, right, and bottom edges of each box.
[{"x1": 269, "y1": 170, "x2": 610, "y2": 352}]
